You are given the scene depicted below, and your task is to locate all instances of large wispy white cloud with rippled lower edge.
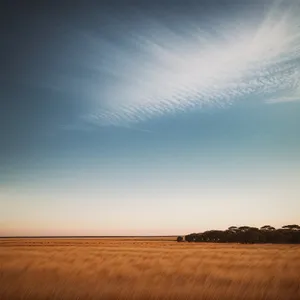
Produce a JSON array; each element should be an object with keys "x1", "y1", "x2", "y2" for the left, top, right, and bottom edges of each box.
[{"x1": 79, "y1": 2, "x2": 300, "y2": 125}]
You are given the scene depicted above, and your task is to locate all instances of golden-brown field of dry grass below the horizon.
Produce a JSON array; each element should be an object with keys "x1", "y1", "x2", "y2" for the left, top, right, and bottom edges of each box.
[{"x1": 0, "y1": 238, "x2": 300, "y2": 300}]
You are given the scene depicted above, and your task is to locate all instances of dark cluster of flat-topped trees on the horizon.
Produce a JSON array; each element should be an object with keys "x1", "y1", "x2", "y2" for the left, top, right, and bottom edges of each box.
[{"x1": 185, "y1": 225, "x2": 300, "y2": 244}]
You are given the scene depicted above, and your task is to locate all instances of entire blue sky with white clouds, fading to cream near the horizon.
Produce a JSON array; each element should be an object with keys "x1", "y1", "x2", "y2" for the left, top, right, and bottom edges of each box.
[{"x1": 0, "y1": 0, "x2": 300, "y2": 236}]
